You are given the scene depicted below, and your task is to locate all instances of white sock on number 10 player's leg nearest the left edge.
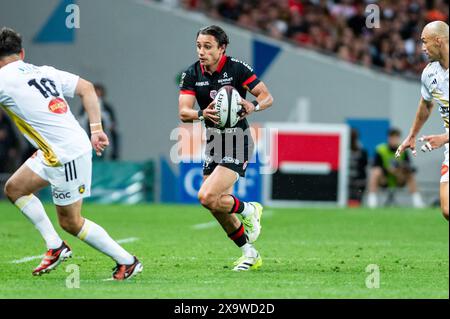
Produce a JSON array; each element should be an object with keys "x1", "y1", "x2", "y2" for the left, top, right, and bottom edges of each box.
[{"x1": 14, "y1": 194, "x2": 62, "y2": 249}]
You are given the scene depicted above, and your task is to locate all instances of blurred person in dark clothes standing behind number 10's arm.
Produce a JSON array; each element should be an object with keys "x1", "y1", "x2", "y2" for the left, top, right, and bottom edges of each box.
[{"x1": 79, "y1": 83, "x2": 120, "y2": 160}]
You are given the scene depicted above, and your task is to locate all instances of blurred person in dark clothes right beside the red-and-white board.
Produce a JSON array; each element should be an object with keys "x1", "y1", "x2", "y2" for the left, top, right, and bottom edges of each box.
[{"x1": 349, "y1": 129, "x2": 368, "y2": 206}]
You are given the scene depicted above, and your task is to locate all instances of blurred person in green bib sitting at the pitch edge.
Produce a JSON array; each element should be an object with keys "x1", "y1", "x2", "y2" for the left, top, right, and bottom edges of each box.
[{"x1": 368, "y1": 129, "x2": 425, "y2": 208}]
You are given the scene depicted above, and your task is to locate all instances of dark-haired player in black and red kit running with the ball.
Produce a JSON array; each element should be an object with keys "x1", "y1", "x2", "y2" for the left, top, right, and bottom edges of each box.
[{"x1": 179, "y1": 25, "x2": 273, "y2": 271}]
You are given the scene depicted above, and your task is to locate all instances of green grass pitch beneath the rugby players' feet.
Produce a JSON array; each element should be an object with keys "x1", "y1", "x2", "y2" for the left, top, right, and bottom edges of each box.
[{"x1": 0, "y1": 202, "x2": 449, "y2": 299}]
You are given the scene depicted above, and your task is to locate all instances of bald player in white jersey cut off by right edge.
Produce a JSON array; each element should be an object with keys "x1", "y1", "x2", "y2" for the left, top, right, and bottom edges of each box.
[{"x1": 397, "y1": 21, "x2": 449, "y2": 220}]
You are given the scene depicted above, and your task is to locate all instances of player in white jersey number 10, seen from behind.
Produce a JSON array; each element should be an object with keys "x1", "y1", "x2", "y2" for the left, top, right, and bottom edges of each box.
[{"x1": 0, "y1": 28, "x2": 142, "y2": 280}]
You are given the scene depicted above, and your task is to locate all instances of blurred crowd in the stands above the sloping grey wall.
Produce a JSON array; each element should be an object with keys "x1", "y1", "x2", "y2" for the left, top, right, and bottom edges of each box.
[{"x1": 156, "y1": 0, "x2": 449, "y2": 78}]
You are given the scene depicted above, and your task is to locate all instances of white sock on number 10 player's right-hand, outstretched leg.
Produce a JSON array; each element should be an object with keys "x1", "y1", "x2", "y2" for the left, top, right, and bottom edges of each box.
[{"x1": 77, "y1": 218, "x2": 134, "y2": 265}]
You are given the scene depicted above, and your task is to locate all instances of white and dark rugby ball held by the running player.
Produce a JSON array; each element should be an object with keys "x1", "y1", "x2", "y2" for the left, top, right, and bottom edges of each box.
[{"x1": 214, "y1": 85, "x2": 242, "y2": 128}]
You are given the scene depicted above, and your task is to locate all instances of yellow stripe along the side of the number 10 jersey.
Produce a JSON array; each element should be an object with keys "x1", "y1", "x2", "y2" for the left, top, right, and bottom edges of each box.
[{"x1": 0, "y1": 104, "x2": 61, "y2": 167}]
